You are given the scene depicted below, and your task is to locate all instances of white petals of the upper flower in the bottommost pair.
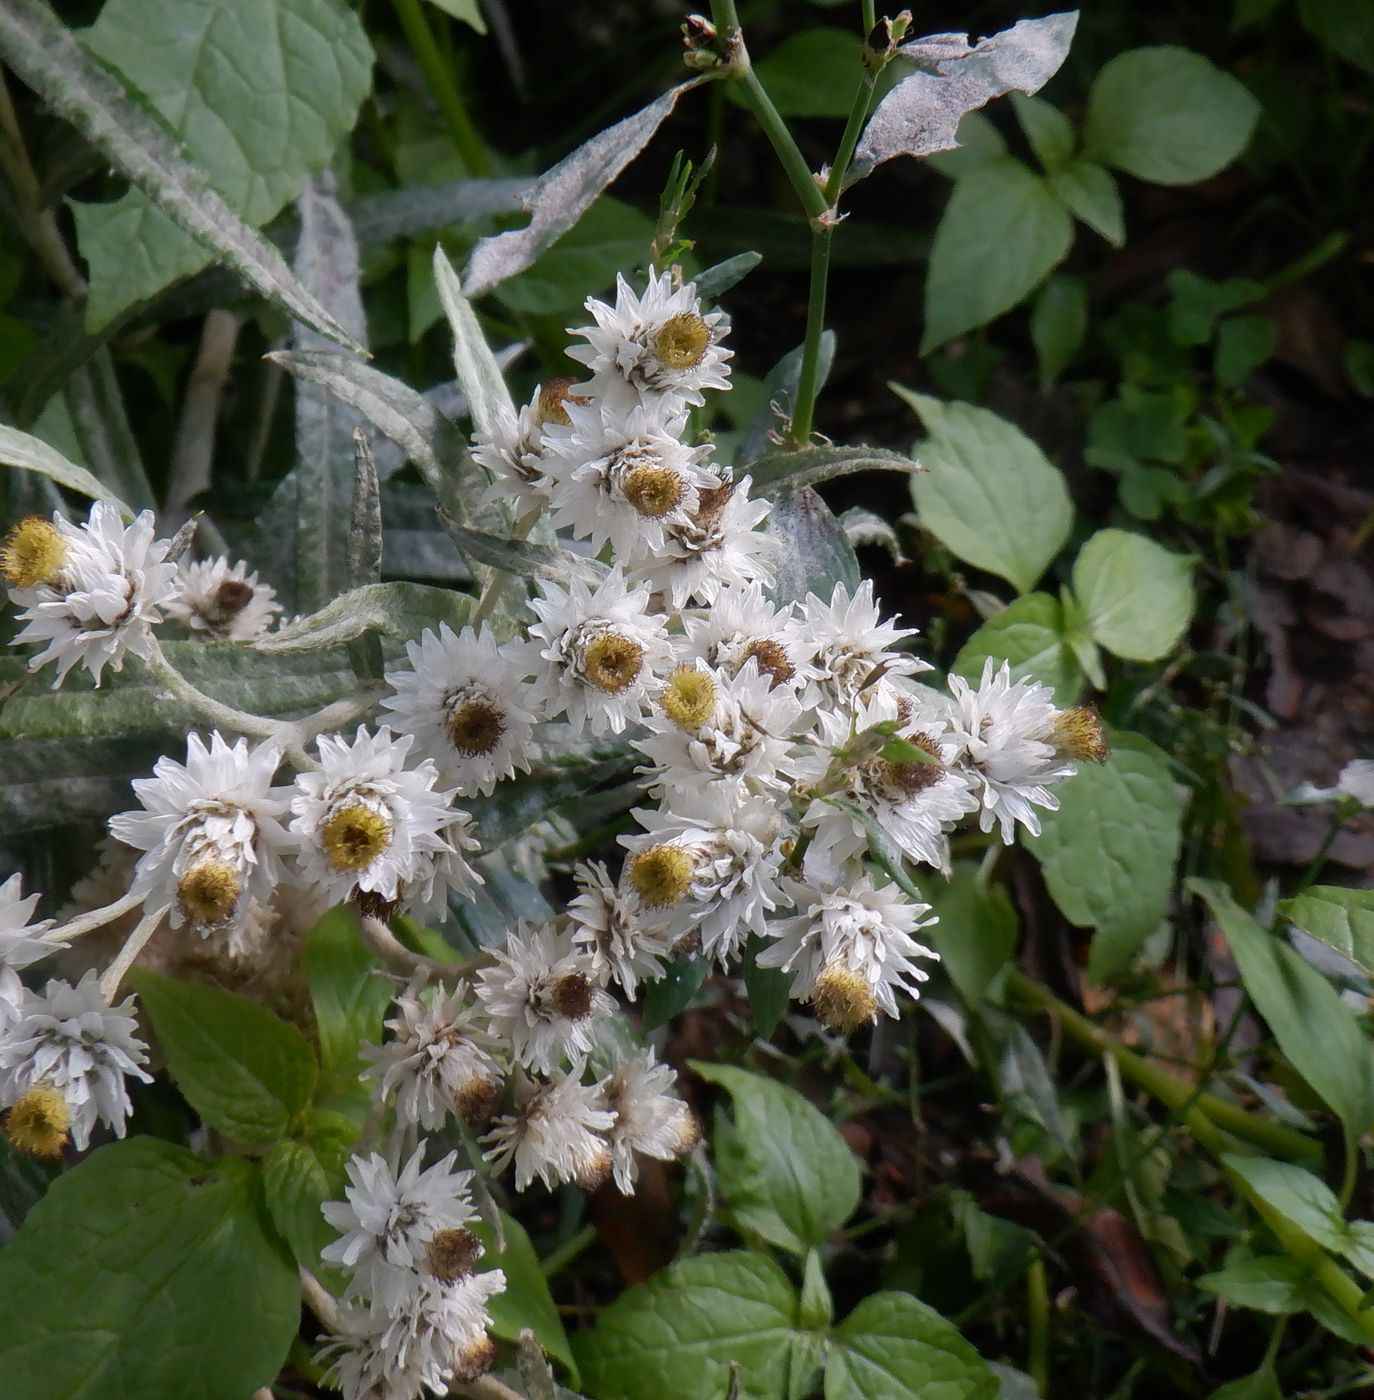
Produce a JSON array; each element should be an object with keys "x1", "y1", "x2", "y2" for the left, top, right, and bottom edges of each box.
[{"x1": 321, "y1": 1142, "x2": 476, "y2": 1316}]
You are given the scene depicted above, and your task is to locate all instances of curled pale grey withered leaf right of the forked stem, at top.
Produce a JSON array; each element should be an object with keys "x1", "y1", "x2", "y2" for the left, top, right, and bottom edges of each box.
[{"x1": 845, "y1": 10, "x2": 1078, "y2": 185}]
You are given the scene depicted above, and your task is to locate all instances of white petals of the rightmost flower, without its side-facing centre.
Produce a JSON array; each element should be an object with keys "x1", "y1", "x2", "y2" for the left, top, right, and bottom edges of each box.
[{"x1": 950, "y1": 657, "x2": 1077, "y2": 846}]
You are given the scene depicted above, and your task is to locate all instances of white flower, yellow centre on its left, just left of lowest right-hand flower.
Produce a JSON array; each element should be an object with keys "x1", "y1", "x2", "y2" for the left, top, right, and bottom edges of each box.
[{"x1": 620, "y1": 787, "x2": 786, "y2": 965}]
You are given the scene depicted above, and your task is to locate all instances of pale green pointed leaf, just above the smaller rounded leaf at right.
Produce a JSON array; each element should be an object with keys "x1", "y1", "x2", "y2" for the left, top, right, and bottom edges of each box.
[{"x1": 891, "y1": 384, "x2": 1073, "y2": 594}]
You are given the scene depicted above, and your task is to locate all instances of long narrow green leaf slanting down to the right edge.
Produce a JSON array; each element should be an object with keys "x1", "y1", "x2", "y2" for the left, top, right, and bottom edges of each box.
[{"x1": 1189, "y1": 881, "x2": 1374, "y2": 1135}]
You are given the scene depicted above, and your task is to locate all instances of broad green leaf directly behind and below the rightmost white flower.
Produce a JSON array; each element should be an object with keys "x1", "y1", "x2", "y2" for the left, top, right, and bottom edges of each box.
[{"x1": 1022, "y1": 734, "x2": 1182, "y2": 980}]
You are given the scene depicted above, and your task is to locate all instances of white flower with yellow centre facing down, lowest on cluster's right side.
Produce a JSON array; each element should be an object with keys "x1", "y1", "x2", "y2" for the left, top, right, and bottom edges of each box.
[{"x1": 759, "y1": 874, "x2": 938, "y2": 1030}]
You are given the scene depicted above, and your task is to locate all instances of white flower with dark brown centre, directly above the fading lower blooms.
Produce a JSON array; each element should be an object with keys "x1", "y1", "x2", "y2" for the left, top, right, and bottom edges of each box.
[{"x1": 478, "y1": 923, "x2": 615, "y2": 1074}]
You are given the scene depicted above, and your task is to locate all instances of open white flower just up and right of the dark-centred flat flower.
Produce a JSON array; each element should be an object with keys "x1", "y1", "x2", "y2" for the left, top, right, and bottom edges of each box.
[{"x1": 527, "y1": 567, "x2": 671, "y2": 734}]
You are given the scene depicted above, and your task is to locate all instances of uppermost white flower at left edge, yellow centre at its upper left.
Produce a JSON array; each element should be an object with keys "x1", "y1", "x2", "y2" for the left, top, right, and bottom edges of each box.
[{"x1": 0, "y1": 501, "x2": 176, "y2": 686}]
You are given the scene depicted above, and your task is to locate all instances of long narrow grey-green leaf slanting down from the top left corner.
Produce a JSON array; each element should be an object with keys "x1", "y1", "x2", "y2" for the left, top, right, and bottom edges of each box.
[{"x1": 0, "y1": 0, "x2": 361, "y2": 350}]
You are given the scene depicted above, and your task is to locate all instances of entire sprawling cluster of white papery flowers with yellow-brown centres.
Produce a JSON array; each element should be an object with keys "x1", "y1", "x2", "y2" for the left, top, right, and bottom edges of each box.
[{"x1": 0, "y1": 273, "x2": 1105, "y2": 1400}]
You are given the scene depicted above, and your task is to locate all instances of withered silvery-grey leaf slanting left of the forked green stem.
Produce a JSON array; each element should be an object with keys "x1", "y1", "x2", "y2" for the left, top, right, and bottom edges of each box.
[{"x1": 462, "y1": 78, "x2": 705, "y2": 297}]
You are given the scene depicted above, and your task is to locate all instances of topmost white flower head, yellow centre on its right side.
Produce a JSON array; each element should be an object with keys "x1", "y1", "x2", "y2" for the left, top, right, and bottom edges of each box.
[{"x1": 567, "y1": 272, "x2": 734, "y2": 413}]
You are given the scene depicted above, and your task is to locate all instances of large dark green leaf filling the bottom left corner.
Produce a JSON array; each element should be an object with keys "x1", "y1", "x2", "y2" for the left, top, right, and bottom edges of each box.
[{"x1": 0, "y1": 1137, "x2": 300, "y2": 1400}]
